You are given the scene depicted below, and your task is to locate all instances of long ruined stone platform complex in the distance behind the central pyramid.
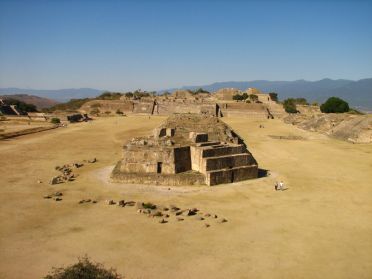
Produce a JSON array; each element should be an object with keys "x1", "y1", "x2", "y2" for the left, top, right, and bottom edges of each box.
[{"x1": 81, "y1": 88, "x2": 284, "y2": 119}]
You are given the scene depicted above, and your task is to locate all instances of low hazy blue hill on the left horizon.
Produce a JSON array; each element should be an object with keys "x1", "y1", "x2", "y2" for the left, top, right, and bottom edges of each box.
[{"x1": 0, "y1": 88, "x2": 103, "y2": 102}]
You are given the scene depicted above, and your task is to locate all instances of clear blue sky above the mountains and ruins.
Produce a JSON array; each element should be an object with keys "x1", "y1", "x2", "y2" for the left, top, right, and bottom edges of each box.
[{"x1": 0, "y1": 0, "x2": 372, "y2": 91}]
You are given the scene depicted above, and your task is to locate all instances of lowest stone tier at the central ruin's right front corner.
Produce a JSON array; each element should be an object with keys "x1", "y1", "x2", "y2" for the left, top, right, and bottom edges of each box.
[{"x1": 206, "y1": 165, "x2": 258, "y2": 186}]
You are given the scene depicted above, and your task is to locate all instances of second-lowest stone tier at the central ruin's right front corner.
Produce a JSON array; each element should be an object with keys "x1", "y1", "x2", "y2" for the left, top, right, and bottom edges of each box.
[{"x1": 201, "y1": 153, "x2": 256, "y2": 172}]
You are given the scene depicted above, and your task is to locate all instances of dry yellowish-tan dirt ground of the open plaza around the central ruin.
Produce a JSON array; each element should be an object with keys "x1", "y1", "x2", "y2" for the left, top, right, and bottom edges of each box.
[{"x1": 0, "y1": 116, "x2": 372, "y2": 279}]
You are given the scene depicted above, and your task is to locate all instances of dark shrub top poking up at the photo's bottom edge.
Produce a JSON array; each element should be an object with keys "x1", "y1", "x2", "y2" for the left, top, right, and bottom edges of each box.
[{"x1": 44, "y1": 256, "x2": 123, "y2": 279}]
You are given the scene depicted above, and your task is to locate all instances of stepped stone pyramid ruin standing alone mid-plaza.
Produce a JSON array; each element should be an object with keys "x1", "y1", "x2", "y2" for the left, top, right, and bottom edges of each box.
[{"x1": 111, "y1": 114, "x2": 258, "y2": 186}]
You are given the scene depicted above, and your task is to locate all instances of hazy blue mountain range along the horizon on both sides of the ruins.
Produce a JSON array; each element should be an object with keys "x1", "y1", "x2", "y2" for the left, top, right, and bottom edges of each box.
[{"x1": 0, "y1": 78, "x2": 372, "y2": 111}]
